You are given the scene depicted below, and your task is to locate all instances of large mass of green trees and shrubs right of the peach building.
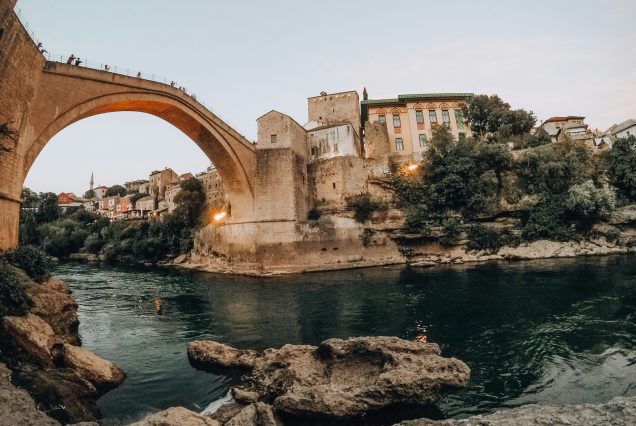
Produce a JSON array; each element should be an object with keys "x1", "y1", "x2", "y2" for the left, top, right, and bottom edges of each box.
[{"x1": 392, "y1": 95, "x2": 636, "y2": 251}]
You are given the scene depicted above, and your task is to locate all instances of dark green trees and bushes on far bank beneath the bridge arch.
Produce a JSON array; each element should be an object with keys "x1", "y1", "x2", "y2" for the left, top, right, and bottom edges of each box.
[{"x1": 20, "y1": 178, "x2": 205, "y2": 263}]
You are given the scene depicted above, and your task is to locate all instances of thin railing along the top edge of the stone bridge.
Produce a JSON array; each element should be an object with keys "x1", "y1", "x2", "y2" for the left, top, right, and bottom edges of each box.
[{"x1": 14, "y1": 7, "x2": 249, "y2": 142}]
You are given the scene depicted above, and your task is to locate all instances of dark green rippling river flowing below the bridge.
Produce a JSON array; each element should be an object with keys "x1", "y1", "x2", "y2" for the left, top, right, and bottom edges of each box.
[{"x1": 55, "y1": 256, "x2": 636, "y2": 424}]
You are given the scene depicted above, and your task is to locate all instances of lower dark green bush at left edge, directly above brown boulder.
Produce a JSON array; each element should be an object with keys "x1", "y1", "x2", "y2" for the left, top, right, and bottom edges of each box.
[{"x1": 0, "y1": 259, "x2": 33, "y2": 318}]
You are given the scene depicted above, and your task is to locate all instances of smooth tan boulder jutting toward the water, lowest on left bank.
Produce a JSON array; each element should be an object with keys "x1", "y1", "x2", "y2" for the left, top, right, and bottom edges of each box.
[{"x1": 62, "y1": 343, "x2": 126, "y2": 392}]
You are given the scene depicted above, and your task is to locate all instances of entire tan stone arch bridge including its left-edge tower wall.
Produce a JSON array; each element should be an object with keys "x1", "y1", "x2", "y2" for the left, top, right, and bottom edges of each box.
[{"x1": 0, "y1": 1, "x2": 256, "y2": 250}]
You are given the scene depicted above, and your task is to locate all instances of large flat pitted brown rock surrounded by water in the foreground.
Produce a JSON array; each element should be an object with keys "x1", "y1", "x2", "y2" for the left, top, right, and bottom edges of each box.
[{"x1": 188, "y1": 337, "x2": 470, "y2": 418}]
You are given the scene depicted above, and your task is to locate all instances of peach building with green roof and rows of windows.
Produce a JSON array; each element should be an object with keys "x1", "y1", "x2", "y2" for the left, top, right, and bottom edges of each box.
[{"x1": 361, "y1": 93, "x2": 473, "y2": 160}]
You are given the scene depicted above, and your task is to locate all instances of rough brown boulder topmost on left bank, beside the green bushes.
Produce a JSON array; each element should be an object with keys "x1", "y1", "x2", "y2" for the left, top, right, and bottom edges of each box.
[{"x1": 28, "y1": 278, "x2": 80, "y2": 345}]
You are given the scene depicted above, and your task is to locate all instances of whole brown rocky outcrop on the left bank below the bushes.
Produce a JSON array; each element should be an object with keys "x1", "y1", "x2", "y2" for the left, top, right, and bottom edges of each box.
[{"x1": 0, "y1": 268, "x2": 125, "y2": 424}]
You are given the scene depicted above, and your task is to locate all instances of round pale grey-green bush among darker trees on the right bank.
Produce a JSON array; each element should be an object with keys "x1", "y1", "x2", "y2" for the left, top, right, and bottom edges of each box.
[{"x1": 565, "y1": 180, "x2": 616, "y2": 228}]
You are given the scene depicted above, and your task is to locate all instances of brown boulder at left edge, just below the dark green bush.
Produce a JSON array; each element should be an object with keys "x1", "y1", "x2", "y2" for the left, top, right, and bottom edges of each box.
[{"x1": 1, "y1": 314, "x2": 55, "y2": 366}]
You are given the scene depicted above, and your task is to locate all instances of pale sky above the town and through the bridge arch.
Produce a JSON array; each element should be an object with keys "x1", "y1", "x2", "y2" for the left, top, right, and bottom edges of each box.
[{"x1": 17, "y1": 0, "x2": 636, "y2": 194}]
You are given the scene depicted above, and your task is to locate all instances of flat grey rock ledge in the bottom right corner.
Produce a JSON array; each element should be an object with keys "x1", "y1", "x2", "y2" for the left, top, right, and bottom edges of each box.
[{"x1": 399, "y1": 397, "x2": 636, "y2": 426}]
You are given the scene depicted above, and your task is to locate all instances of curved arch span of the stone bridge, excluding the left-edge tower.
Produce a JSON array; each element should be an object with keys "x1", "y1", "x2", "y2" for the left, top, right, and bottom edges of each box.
[{"x1": 12, "y1": 62, "x2": 256, "y2": 228}]
